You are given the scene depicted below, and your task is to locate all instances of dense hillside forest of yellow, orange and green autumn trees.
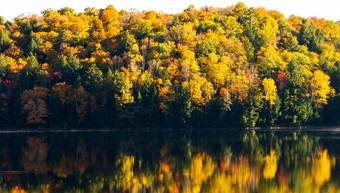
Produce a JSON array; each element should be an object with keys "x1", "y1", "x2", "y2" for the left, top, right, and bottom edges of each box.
[{"x1": 0, "y1": 3, "x2": 340, "y2": 128}]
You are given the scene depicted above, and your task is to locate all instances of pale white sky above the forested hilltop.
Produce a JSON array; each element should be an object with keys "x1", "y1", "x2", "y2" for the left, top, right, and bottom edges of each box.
[{"x1": 0, "y1": 0, "x2": 340, "y2": 21}]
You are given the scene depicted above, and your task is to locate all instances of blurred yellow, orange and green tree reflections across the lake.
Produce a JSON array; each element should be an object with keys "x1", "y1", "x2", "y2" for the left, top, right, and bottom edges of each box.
[{"x1": 0, "y1": 131, "x2": 340, "y2": 193}]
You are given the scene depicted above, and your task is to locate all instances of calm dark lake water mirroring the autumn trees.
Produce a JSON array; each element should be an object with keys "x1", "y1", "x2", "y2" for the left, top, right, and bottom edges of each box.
[{"x1": 0, "y1": 130, "x2": 340, "y2": 193}]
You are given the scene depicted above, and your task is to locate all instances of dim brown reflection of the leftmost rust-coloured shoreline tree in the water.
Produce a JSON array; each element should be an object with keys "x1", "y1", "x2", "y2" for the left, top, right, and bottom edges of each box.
[{"x1": 22, "y1": 137, "x2": 49, "y2": 174}]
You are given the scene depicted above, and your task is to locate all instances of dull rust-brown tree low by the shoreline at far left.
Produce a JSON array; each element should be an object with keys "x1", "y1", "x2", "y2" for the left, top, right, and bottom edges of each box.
[{"x1": 20, "y1": 87, "x2": 50, "y2": 124}]
